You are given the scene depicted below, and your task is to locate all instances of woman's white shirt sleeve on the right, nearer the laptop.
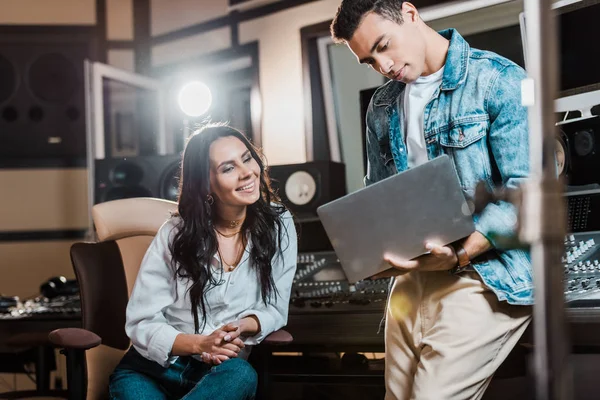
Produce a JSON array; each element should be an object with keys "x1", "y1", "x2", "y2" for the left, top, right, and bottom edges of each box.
[{"x1": 239, "y1": 212, "x2": 298, "y2": 345}]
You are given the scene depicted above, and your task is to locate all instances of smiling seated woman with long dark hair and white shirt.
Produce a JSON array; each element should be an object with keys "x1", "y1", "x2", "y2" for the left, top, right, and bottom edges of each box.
[{"x1": 110, "y1": 125, "x2": 297, "y2": 399}]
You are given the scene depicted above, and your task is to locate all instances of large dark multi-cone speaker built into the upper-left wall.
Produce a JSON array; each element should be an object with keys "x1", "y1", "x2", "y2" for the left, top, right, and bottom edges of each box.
[{"x1": 0, "y1": 27, "x2": 93, "y2": 159}]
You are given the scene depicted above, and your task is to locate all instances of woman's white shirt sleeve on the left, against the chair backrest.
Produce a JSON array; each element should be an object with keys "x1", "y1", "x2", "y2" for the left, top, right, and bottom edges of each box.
[{"x1": 125, "y1": 221, "x2": 181, "y2": 367}]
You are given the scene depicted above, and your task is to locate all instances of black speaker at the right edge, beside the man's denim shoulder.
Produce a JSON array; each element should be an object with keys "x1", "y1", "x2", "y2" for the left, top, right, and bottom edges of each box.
[{"x1": 557, "y1": 116, "x2": 600, "y2": 186}]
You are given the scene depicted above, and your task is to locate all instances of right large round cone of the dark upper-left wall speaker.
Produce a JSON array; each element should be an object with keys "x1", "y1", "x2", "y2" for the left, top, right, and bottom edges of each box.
[{"x1": 29, "y1": 53, "x2": 77, "y2": 104}]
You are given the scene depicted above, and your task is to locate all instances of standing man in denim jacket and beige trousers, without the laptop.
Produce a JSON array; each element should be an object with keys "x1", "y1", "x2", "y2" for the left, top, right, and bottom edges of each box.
[{"x1": 331, "y1": 0, "x2": 533, "y2": 400}]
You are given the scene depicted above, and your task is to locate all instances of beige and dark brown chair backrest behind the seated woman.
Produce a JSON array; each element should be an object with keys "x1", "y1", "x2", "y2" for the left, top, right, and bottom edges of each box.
[{"x1": 71, "y1": 198, "x2": 177, "y2": 400}]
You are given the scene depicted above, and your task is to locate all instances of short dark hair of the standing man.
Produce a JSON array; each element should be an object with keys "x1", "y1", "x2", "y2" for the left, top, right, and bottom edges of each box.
[{"x1": 331, "y1": 0, "x2": 405, "y2": 43}]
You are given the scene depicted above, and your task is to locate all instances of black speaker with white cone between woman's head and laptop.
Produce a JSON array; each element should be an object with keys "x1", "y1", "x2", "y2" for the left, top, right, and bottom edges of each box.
[{"x1": 269, "y1": 161, "x2": 346, "y2": 219}]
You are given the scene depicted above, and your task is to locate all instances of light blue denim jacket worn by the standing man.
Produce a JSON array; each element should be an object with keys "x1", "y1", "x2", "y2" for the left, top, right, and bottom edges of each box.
[{"x1": 365, "y1": 29, "x2": 533, "y2": 305}]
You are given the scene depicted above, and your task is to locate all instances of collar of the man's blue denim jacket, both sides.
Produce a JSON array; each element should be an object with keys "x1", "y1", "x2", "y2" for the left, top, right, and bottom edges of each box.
[{"x1": 374, "y1": 29, "x2": 470, "y2": 106}]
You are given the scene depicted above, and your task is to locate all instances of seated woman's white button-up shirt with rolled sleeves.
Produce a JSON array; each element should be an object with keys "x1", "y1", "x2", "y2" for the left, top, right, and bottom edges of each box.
[{"x1": 125, "y1": 212, "x2": 298, "y2": 366}]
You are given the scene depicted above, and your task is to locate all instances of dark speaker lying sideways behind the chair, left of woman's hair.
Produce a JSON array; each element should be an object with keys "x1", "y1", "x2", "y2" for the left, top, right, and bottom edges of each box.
[{"x1": 95, "y1": 154, "x2": 181, "y2": 204}]
